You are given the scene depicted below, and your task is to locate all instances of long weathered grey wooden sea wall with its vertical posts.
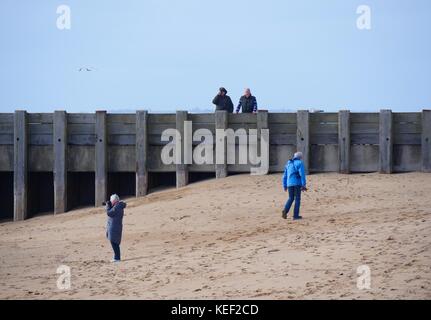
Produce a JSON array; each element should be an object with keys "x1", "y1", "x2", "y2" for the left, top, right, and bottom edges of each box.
[{"x1": 0, "y1": 110, "x2": 431, "y2": 220}]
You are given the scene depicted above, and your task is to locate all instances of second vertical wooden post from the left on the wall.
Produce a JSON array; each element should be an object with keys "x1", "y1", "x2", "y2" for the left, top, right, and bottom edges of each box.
[{"x1": 53, "y1": 111, "x2": 67, "y2": 214}]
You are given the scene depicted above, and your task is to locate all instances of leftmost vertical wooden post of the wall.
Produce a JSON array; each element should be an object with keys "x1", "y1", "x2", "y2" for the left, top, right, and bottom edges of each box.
[{"x1": 13, "y1": 110, "x2": 27, "y2": 221}]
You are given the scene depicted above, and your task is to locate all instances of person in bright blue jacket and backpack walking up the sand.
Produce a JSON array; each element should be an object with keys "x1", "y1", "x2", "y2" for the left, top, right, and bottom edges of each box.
[{"x1": 282, "y1": 152, "x2": 307, "y2": 220}]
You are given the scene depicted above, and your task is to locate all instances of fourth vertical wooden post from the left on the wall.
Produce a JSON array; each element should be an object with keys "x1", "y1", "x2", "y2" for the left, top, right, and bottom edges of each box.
[{"x1": 135, "y1": 111, "x2": 148, "y2": 197}]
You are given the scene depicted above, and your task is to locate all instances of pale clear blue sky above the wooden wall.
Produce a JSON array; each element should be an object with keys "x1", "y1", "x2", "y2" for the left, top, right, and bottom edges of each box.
[{"x1": 0, "y1": 0, "x2": 431, "y2": 112}]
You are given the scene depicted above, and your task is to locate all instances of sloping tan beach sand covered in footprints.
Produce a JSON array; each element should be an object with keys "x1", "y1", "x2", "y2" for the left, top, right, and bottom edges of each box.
[{"x1": 0, "y1": 173, "x2": 431, "y2": 299}]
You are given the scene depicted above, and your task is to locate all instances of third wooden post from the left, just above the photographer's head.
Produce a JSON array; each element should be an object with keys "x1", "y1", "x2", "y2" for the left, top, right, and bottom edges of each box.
[{"x1": 94, "y1": 111, "x2": 108, "y2": 207}]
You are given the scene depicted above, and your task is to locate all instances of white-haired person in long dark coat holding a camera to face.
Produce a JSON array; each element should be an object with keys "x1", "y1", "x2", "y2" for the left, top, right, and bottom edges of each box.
[{"x1": 106, "y1": 194, "x2": 126, "y2": 262}]
